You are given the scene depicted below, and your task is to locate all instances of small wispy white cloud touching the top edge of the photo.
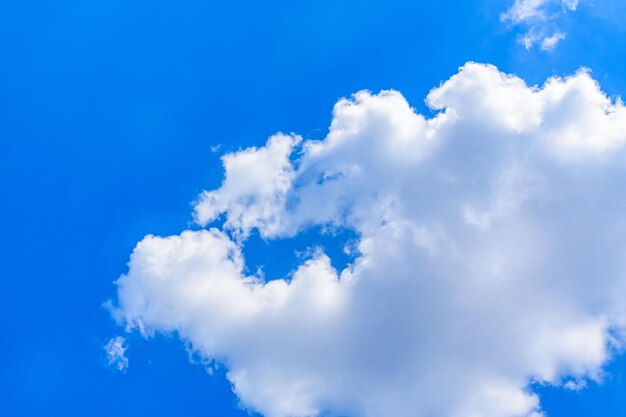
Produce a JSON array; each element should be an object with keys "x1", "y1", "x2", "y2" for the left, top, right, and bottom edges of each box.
[{"x1": 500, "y1": 0, "x2": 578, "y2": 51}]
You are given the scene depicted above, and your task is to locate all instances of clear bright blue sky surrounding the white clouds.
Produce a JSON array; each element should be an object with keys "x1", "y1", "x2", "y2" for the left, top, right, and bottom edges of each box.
[{"x1": 0, "y1": 0, "x2": 626, "y2": 417}]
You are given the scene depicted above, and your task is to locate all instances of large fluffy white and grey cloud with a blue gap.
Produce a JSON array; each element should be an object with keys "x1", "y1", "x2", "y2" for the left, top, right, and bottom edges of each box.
[{"x1": 109, "y1": 63, "x2": 626, "y2": 417}]
